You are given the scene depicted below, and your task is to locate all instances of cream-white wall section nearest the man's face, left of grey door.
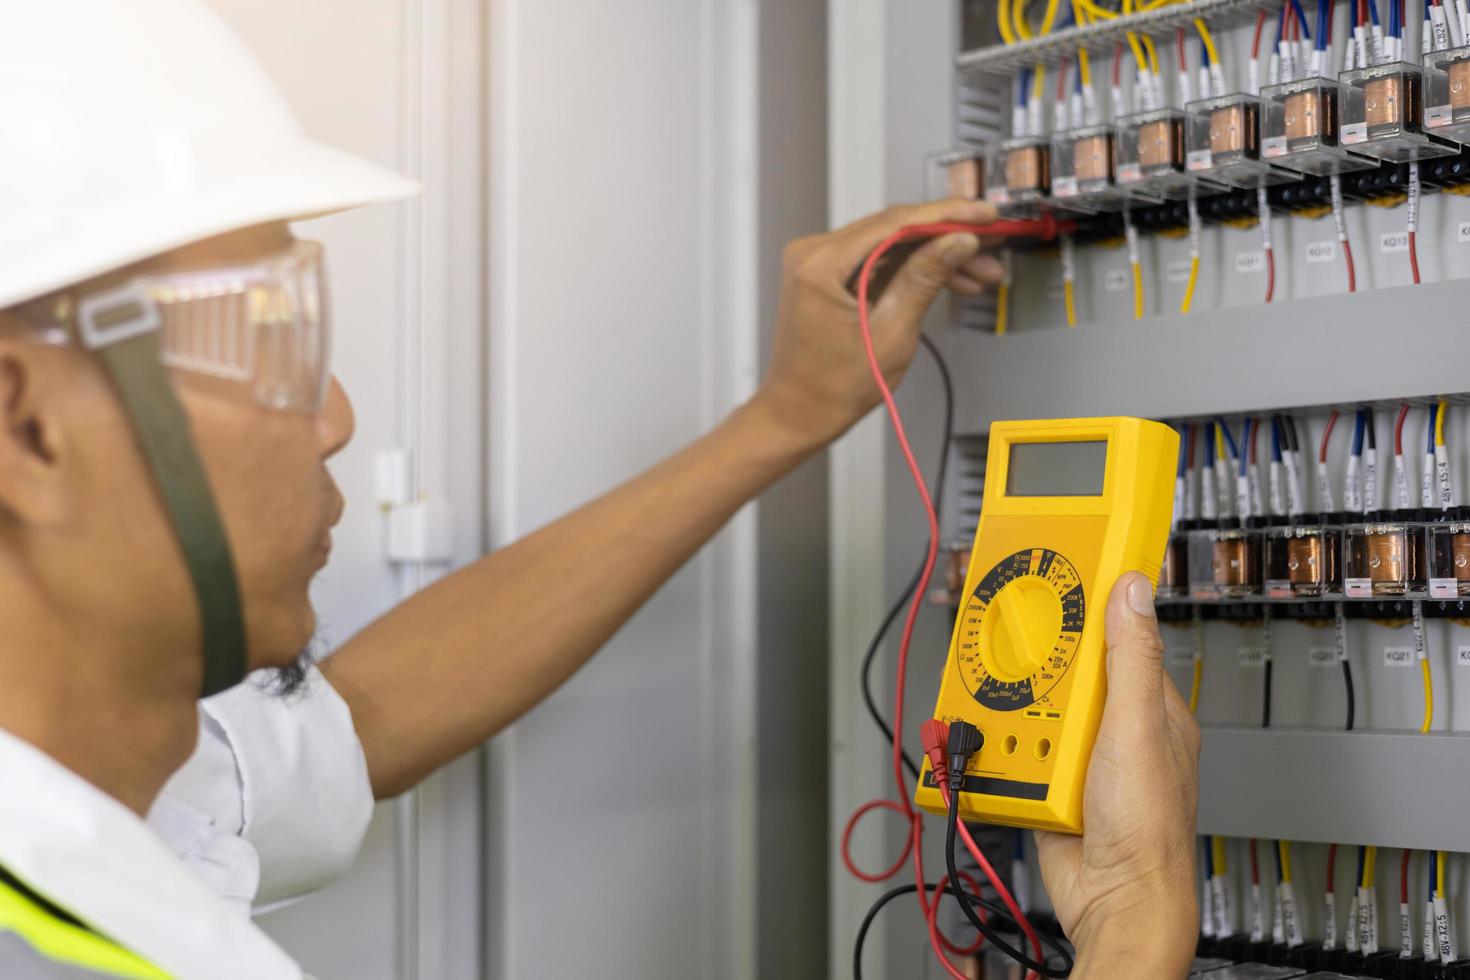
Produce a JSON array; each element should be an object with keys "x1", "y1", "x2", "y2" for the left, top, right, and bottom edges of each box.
[{"x1": 195, "y1": 0, "x2": 484, "y2": 980}]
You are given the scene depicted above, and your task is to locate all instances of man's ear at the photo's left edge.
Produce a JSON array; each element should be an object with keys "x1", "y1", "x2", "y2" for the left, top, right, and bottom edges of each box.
[{"x1": 0, "y1": 335, "x2": 75, "y2": 523}]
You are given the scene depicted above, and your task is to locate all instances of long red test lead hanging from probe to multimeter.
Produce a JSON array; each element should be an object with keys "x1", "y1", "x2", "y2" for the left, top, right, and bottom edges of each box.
[{"x1": 842, "y1": 222, "x2": 1042, "y2": 980}]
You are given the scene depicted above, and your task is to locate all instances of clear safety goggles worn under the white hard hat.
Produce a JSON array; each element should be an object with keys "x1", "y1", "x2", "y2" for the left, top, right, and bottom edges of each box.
[{"x1": 15, "y1": 241, "x2": 331, "y2": 413}]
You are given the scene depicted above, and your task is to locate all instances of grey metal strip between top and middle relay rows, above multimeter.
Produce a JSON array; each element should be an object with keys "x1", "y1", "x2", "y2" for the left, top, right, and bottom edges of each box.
[{"x1": 944, "y1": 281, "x2": 1470, "y2": 432}]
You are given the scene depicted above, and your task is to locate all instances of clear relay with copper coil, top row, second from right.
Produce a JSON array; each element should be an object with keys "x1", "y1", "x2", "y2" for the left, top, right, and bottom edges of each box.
[{"x1": 1338, "y1": 62, "x2": 1460, "y2": 163}]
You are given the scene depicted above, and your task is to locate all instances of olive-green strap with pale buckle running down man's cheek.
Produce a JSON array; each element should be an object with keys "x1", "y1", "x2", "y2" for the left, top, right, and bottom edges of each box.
[{"x1": 76, "y1": 287, "x2": 247, "y2": 696}]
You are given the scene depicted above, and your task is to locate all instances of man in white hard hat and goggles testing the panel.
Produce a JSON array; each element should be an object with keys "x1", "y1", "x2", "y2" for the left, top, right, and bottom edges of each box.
[{"x1": 0, "y1": 0, "x2": 1195, "y2": 980}]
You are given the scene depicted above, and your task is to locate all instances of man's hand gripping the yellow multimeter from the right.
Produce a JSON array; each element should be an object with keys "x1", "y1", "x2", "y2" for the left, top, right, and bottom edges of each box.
[{"x1": 1036, "y1": 572, "x2": 1200, "y2": 980}]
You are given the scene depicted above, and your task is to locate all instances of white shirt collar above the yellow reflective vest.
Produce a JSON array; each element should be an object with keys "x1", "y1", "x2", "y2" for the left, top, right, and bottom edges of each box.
[{"x1": 0, "y1": 729, "x2": 301, "y2": 980}]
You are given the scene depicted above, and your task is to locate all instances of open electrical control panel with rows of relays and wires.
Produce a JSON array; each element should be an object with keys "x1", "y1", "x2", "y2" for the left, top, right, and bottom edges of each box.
[{"x1": 846, "y1": 0, "x2": 1470, "y2": 980}]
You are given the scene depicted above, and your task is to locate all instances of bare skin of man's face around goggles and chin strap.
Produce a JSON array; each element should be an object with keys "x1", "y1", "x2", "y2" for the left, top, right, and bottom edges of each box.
[{"x1": 0, "y1": 225, "x2": 353, "y2": 687}]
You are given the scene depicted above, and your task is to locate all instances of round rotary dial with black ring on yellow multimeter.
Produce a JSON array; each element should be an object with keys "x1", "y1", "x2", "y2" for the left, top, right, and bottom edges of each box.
[{"x1": 956, "y1": 548, "x2": 1086, "y2": 711}]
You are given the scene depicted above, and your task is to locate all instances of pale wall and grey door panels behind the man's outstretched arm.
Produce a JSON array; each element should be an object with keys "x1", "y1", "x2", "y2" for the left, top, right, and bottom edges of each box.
[{"x1": 210, "y1": 0, "x2": 828, "y2": 980}]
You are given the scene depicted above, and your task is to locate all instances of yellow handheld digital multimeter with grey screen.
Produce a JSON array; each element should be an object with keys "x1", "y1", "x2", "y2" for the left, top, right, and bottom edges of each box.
[{"x1": 914, "y1": 419, "x2": 1179, "y2": 833}]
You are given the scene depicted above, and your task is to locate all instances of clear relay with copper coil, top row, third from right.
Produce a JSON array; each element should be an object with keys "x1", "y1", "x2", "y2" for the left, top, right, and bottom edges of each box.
[{"x1": 1261, "y1": 78, "x2": 1377, "y2": 176}]
